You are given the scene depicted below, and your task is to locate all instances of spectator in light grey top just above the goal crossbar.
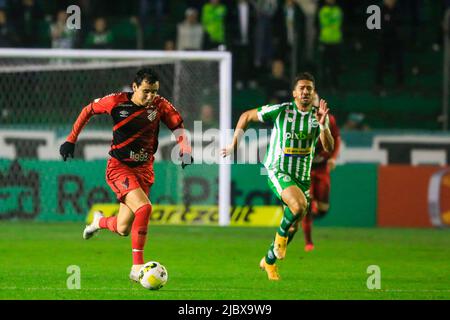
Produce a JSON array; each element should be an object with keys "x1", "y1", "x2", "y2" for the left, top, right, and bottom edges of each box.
[{"x1": 177, "y1": 8, "x2": 203, "y2": 50}]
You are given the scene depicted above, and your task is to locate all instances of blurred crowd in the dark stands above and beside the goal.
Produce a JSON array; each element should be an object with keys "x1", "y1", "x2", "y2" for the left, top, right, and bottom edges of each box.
[{"x1": 0, "y1": 0, "x2": 450, "y2": 130}]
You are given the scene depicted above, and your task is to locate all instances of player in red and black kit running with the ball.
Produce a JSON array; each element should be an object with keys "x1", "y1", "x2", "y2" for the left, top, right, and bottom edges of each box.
[{"x1": 60, "y1": 69, "x2": 193, "y2": 281}]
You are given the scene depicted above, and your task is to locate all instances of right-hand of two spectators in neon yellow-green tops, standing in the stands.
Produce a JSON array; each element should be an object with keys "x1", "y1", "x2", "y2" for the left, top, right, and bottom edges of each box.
[{"x1": 319, "y1": 0, "x2": 343, "y2": 91}]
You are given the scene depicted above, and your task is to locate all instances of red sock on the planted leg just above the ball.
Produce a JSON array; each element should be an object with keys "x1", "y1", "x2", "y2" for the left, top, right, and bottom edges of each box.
[{"x1": 131, "y1": 204, "x2": 152, "y2": 264}]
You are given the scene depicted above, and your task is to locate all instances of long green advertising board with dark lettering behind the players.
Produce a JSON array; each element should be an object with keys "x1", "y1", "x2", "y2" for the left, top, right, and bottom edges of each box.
[{"x1": 0, "y1": 160, "x2": 377, "y2": 227}]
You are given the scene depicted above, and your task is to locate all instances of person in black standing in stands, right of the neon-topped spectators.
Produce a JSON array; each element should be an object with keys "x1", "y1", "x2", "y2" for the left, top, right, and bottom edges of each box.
[{"x1": 375, "y1": 0, "x2": 404, "y2": 95}]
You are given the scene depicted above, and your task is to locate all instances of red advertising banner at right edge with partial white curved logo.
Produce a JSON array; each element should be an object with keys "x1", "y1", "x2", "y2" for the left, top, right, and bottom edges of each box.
[{"x1": 377, "y1": 165, "x2": 450, "y2": 227}]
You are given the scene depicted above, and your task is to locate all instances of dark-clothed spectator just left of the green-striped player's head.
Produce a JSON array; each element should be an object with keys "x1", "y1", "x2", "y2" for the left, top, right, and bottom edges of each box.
[{"x1": 263, "y1": 59, "x2": 292, "y2": 104}]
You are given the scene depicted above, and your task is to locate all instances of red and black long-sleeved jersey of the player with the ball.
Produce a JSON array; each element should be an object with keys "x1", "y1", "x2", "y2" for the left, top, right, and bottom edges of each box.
[{"x1": 67, "y1": 92, "x2": 183, "y2": 167}]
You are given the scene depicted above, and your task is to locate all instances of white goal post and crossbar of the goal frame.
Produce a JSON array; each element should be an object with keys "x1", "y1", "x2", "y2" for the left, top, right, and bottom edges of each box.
[{"x1": 0, "y1": 48, "x2": 232, "y2": 226}]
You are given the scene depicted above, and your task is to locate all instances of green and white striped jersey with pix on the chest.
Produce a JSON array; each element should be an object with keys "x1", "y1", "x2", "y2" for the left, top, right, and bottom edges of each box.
[{"x1": 257, "y1": 101, "x2": 328, "y2": 181}]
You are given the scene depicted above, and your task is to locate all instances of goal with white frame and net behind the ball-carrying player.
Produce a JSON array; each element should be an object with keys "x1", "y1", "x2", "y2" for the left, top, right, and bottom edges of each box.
[{"x1": 0, "y1": 49, "x2": 231, "y2": 225}]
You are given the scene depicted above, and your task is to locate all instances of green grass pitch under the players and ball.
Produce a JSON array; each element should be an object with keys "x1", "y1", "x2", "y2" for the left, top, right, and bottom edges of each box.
[{"x1": 0, "y1": 222, "x2": 450, "y2": 300}]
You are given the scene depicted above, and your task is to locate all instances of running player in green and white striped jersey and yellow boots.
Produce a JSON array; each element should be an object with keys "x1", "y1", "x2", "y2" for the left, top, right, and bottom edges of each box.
[{"x1": 222, "y1": 72, "x2": 334, "y2": 280}]
